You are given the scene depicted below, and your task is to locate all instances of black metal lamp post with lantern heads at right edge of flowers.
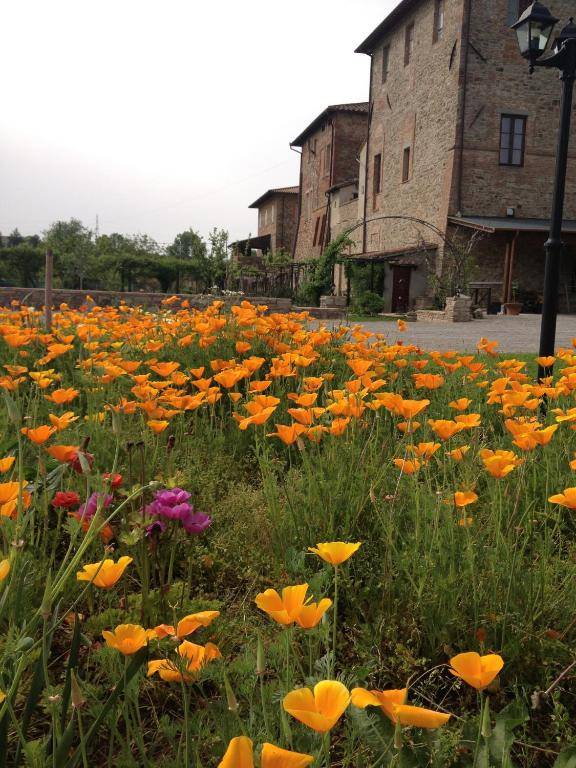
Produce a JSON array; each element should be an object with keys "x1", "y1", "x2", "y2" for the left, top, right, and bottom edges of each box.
[{"x1": 512, "y1": 3, "x2": 576, "y2": 380}]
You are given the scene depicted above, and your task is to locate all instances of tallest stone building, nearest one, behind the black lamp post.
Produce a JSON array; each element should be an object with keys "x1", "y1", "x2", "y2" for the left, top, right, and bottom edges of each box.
[{"x1": 348, "y1": 0, "x2": 576, "y2": 311}]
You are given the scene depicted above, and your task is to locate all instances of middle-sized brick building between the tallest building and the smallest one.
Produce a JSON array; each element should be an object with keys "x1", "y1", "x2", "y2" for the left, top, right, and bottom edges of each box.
[{"x1": 290, "y1": 102, "x2": 368, "y2": 262}]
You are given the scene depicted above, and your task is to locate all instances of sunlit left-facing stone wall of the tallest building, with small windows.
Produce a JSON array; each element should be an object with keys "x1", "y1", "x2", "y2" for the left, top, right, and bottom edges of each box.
[{"x1": 366, "y1": 0, "x2": 468, "y2": 260}]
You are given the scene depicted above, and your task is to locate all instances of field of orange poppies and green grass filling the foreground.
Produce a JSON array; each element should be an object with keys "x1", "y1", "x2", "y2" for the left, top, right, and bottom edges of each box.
[{"x1": 0, "y1": 297, "x2": 576, "y2": 768}]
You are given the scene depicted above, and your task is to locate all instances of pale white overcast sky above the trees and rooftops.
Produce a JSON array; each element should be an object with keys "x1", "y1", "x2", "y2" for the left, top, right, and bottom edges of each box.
[{"x1": 0, "y1": 0, "x2": 397, "y2": 242}]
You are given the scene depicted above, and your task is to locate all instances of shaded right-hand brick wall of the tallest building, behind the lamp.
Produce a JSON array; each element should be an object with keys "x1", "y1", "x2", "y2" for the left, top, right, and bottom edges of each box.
[{"x1": 462, "y1": 0, "x2": 576, "y2": 219}]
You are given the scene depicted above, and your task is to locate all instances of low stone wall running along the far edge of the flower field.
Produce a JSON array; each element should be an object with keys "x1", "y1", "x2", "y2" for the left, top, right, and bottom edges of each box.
[{"x1": 0, "y1": 287, "x2": 344, "y2": 319}]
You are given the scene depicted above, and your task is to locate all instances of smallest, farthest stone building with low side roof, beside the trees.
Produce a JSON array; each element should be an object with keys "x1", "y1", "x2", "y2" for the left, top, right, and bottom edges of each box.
[{"x1": 230, "y1": 187, "x2": 299, "y2": 261}]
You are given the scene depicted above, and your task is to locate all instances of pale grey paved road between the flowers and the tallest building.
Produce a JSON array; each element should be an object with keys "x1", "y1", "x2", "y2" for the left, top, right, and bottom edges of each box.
[{"x1": 328, "y1": 315, "x2": 576, "y2": 354}]
